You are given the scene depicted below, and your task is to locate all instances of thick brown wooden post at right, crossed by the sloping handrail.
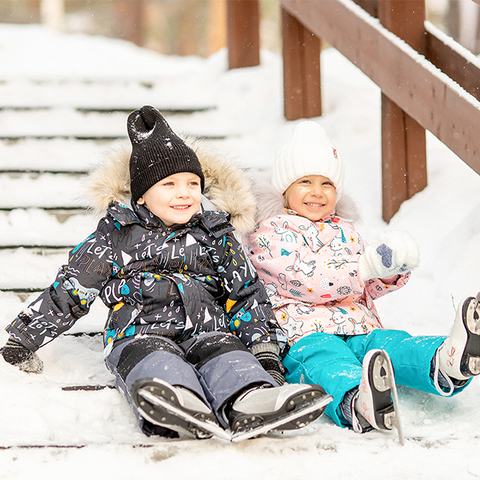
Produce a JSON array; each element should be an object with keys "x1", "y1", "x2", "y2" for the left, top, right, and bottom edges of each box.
[{"x1": 378, "y1": 0, "x2": 427, "y2": 222}]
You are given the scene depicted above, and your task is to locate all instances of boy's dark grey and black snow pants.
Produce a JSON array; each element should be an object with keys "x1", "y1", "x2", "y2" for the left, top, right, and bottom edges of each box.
[{"x1": 105, "y1": 332, "x2": 277, "y2": 436}]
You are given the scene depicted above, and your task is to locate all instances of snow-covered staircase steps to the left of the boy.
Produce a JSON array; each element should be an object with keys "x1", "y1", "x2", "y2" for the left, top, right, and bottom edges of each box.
[{"x1": 0, "y1": 96, "x2": 219, "y2": 295}]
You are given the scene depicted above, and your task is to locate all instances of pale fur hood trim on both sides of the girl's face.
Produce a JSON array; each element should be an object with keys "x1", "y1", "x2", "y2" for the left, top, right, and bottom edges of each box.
[{"x1": 251, "y1": 172, "x2": 360, "y2": 223}]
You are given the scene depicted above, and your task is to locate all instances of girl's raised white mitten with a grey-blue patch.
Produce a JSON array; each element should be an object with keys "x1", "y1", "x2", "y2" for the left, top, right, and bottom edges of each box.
[{"x1": 358, "y1": 231, "x2": 420, "y2": 281}]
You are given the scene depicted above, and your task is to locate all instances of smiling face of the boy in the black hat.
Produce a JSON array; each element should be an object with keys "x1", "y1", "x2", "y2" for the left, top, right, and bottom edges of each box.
[{"x1": 137, "y1": 172, "x2": 202, "y2": 227}]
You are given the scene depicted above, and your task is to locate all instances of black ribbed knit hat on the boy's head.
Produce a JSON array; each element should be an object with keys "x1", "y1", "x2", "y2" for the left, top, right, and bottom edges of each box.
[{"x1": 127, "y1": 105, "x2": 205, "y2": 202}]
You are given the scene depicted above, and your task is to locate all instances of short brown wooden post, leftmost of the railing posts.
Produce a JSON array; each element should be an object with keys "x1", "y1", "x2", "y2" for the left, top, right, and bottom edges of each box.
[{"x1": 227, "y1": 0, "x2": 260, "y2": 69}]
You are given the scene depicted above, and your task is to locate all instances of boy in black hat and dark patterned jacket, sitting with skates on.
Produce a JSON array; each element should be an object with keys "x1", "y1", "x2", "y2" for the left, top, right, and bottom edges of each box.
[{"x1": 2, "y1": 106, "x2": 329, "y2": 439}]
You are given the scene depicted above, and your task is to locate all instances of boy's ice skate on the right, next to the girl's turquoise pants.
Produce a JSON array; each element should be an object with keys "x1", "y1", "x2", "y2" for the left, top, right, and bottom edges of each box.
[{"x1": 229, "y1": 384, "x2": 332, "y2": 442}]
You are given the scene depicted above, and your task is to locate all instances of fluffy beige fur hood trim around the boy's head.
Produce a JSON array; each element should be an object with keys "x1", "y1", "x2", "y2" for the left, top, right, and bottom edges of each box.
[{"x1": 85, "y1": 138, "x2": 256, "y2": 235}]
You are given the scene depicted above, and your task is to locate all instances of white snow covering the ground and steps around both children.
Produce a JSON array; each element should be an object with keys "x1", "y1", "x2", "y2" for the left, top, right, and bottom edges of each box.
[{"x1": 0, "y1": 21, "x2": 480, "y2": 480}]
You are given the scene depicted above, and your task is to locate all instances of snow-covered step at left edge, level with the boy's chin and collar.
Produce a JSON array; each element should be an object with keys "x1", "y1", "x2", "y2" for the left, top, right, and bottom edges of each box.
[{"x1": 0, "y1": 208, "x2": 98, "y2": 249}]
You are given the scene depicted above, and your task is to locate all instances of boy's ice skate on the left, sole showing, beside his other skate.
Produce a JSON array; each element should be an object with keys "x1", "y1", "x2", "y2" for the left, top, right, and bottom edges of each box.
[{"x1": 131, "y1": 378, "x2": 231, "y2": 440}]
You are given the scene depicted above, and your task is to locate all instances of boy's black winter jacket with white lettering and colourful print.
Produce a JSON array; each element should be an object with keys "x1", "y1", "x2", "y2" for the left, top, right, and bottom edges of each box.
[{"x1": 7, "y1": 137, "x2": 288, "y2": 354}]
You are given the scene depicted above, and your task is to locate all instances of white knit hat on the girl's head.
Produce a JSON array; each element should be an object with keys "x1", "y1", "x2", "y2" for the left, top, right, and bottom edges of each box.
[{"x1": 272, "y1": 120, "x2": 344, "y2": 201}]
